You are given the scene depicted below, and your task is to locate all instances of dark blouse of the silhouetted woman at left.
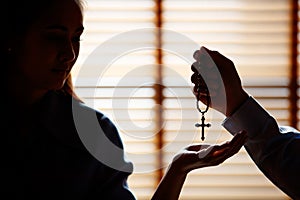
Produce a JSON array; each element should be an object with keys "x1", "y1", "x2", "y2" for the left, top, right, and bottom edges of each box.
[{"x1": 1, "y1": 92, "x2": 135, "y2": 200}]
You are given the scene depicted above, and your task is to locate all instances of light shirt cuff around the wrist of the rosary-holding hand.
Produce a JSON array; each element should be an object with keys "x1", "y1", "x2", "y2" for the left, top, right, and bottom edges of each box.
[{"x1": 222, "y1": 96, "x2": 270, "y2": 138}]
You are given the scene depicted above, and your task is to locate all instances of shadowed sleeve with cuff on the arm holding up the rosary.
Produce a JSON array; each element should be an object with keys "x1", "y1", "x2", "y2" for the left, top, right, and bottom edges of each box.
[{"x1": 222, "y1": 97, "x2": 300, "y2": 199}]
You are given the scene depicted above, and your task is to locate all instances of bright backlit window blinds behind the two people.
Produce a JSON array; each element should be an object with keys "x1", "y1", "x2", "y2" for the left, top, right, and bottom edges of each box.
[{"x1": 72, "y1": 0, "x2": 299, "y2": 200}]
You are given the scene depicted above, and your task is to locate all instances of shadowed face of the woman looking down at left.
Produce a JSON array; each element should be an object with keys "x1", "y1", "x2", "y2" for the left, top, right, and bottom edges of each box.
[{"x1": 16, "y1": 0, "x2": 83, "y2": 90}]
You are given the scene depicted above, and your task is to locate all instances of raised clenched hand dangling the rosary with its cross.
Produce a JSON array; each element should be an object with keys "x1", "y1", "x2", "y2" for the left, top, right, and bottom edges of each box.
[{"x1": 191, "y1": 47, "x2": 249, "y2": 116}]
